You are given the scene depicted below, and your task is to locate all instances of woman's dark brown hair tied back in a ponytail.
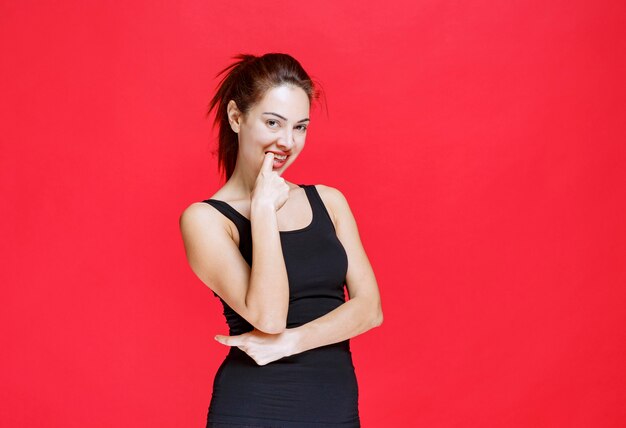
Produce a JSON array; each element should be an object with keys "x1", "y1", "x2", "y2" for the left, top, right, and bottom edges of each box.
[{"x1": 207, "y1": 53, "x2": 322, "y2": 180}]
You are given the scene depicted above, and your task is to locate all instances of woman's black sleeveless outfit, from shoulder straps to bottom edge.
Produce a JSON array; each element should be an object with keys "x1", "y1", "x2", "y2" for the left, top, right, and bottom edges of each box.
[{"x1": 203, "y1": 184, "x2": 360, "y2": 428}]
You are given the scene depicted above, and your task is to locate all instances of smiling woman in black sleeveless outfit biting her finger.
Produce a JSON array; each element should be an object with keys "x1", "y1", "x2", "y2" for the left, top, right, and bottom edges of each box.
[{"x1": 180, "y1": 53, "x2": 383, "y2": 428}]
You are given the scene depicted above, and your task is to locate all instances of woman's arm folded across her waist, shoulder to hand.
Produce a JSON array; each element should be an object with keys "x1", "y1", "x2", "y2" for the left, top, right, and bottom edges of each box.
[{"x1": 215, "y1": 184, "x2": 383, "y2": 365}]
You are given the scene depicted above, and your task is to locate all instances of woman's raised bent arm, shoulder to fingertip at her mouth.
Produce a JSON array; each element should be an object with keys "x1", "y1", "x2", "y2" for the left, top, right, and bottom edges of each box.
[{"x1": 180, "y1": 155, "x2": 289, "y2": 334}]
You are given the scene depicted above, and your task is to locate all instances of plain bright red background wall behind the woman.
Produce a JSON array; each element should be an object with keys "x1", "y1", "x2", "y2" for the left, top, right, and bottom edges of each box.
[{"x1": 0, "y1": 0, "x2": 626, "y2": 428}]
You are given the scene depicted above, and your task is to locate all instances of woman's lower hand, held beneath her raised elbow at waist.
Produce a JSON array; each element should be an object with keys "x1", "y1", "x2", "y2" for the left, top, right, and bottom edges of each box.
[{"x1": 215, "y1": 328, "x2": 298, "y2": 366}]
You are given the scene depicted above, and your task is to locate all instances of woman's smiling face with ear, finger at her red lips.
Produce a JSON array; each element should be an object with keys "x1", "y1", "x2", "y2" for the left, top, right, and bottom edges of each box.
[{"x1": 228, "y1": 85, "x2": 310, "y2": 175}]
